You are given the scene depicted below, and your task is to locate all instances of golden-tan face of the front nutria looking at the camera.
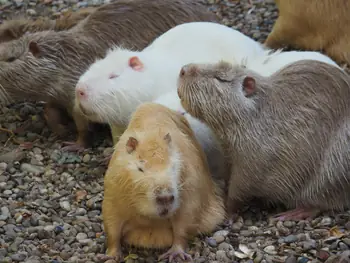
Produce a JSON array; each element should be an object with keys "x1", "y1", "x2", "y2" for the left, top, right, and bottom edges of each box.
[{"x1": 117, "y1": 130, "x2": 181, "y2": 221}]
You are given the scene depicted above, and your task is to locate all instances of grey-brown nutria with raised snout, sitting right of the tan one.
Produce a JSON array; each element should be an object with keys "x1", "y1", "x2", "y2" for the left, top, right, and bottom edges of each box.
[{"x1": 178, "y1": 60, "x2": 350, "y2": 223}]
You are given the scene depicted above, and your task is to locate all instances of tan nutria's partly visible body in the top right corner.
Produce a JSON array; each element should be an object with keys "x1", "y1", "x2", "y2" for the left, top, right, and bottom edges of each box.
[{"x1": 265, "y1": 0, "x2": 350, "y2": 63}]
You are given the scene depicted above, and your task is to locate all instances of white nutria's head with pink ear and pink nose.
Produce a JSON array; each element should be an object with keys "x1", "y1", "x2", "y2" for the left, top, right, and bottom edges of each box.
[{"x1": 75, "y1": 47, "x2": 163, "y2": 125}]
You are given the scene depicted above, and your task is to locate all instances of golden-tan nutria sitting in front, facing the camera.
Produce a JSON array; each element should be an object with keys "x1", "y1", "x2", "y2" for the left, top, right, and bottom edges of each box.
[{"x1": 102, "y1": 102, "x2": 225, "y2": 261}]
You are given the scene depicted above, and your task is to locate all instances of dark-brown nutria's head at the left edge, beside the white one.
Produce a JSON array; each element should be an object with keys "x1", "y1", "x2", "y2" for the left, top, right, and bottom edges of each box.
[{"x1": 0, "y1": 31, "x2": 100, "y2": 107}]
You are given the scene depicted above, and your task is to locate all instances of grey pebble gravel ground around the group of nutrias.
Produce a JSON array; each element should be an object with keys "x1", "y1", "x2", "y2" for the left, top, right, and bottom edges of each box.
[{"x1": 0, "y1": 0, "x2": 350, "y2": 263}]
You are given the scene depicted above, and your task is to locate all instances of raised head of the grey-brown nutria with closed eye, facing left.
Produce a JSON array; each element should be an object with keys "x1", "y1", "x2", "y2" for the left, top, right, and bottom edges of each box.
[{"x1": 178, "y1": 61, "x2": 261, "y2": 131}]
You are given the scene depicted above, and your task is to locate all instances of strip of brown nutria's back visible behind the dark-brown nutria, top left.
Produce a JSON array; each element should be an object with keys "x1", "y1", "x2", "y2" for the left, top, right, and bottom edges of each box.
[{"x1": 0, "y1": 7, "x2": 97, "y2": 43}]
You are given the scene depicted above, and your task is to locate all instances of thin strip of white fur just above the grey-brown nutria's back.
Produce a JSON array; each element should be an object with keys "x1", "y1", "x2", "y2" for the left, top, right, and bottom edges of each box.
[{"x1": 245, "y1": 50, "x2": 340, "y2": 76}]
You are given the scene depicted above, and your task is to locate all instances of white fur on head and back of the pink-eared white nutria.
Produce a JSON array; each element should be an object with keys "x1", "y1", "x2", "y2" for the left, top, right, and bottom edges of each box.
[{"x1": 74, "y1": 22, "x2": 264, "y2": 125}]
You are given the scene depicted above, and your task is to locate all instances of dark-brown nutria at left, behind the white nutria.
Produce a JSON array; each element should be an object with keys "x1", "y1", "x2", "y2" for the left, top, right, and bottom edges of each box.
[{"x1": 0, "y1": 0, "x2": 217, "y2": 152}]
